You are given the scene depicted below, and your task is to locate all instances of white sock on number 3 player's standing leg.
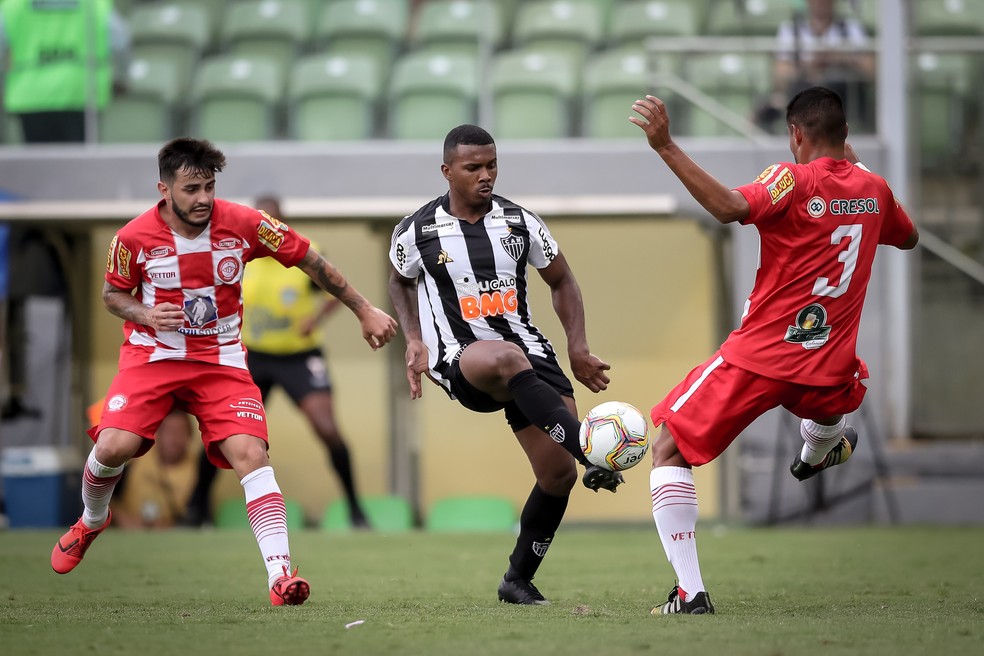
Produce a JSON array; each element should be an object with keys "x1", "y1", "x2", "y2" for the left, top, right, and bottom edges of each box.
[{"x1": 649, "y1": 467, "x2": 704, "y2": 601}]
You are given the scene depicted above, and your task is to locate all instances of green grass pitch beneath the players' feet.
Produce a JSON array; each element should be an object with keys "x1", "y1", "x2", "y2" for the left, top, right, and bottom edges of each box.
[{"x1": 0, "y1": 526, "x2": 984, "y2": 656}]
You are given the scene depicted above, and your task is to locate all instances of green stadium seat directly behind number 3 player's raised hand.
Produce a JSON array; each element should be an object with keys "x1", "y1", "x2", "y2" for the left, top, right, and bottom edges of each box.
[{"x1": 581, "y1": 48, "x2": 656, "y2": 139}]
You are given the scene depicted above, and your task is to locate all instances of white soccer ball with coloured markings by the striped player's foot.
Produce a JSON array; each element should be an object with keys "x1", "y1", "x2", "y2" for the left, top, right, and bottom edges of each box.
[{"x1": 578, "y1": 401, "x2": 649, "y2": 471}]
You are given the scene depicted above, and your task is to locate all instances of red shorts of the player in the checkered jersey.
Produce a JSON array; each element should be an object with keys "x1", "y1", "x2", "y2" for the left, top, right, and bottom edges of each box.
[{"x1": 88, "y1": 360, "x2": 268, "y2": 469}]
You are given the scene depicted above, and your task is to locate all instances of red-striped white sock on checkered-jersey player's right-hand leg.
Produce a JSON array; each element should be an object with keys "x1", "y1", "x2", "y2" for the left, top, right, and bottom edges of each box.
[{"x1": 239, "y1": 466, "x2": 290, "y2": 588}]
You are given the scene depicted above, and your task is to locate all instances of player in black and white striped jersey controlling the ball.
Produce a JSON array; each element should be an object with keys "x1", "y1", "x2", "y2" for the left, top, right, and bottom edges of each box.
[{"x1": 389, "y1": 125, "x2": 622, "y2": 604}]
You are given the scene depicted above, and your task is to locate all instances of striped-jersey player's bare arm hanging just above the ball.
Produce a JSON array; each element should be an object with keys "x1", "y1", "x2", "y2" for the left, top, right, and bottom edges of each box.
[{"x1": 539, "y1": 253, "x2": 612, "y2": 392}]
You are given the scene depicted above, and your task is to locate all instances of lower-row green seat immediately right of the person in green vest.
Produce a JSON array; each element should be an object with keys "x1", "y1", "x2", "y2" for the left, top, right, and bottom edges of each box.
[{"x1": 99, "y1": 58, "x2": 184, "y2": 143}]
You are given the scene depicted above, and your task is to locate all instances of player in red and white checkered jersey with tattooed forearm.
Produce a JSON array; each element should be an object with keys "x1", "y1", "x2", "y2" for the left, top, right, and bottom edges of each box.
[{"x1": 51, "y1": 138, "x2": 396, "y2": 606}]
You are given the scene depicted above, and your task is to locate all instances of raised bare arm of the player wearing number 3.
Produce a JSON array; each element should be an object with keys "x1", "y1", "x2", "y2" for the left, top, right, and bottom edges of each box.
[{"x1": 629, "y1": 96, "x2": 750, "y2": 223}]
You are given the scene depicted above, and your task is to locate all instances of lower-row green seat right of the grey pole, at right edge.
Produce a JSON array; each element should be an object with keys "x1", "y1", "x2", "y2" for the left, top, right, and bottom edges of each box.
[{"x1": 912, "y1": 52, "x2": 980, "y2": 168}]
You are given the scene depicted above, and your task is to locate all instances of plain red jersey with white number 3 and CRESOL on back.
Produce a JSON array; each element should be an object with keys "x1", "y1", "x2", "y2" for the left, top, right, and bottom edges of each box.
[{"x1": 721, "y1": 157, "x2": 912, "y2": 386}]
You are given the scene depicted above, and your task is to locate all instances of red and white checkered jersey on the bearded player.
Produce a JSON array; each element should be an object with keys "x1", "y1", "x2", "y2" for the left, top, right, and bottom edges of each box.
[{"x1": 106, "y1": 198, "x2": 310, "y2": 370}]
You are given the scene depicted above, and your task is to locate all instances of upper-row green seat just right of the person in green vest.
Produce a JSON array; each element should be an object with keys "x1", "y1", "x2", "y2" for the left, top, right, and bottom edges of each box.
[{"x1": 127, "y1": 2, "x2": 212, "y2": 89}]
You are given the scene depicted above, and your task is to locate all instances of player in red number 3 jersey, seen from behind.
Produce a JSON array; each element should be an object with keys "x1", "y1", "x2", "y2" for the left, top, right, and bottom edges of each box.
[{"x1": 629, "y1": 87, "x2": 919, "y2": 614}]
